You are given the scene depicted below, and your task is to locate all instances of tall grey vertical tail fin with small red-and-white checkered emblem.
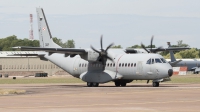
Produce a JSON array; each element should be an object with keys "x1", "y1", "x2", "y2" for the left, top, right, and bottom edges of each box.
[{"x1": 36, "y1": 8, "x2": 60, "y2": 48}]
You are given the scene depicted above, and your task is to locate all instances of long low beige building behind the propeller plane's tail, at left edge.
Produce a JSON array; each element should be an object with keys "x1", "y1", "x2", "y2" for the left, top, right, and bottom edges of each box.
[{"x1": 0, "y1": 51, "x2": 69, "y2": 76}]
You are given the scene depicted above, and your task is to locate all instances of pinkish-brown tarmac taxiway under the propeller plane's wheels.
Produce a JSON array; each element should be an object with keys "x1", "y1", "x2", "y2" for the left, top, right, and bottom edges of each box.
[{"x1": 0, "y1": 83, "x2": 200, "y2": 112}]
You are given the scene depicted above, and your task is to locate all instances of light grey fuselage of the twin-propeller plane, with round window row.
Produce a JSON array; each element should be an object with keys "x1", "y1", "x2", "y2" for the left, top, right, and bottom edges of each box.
[{"x1": 45, "y1": 49, "x2": 172, "y2": 83}]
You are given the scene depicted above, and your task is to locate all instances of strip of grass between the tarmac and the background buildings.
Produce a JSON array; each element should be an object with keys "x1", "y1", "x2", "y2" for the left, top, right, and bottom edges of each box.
[{"x1": 0, "y1": 75, "x2": 200, "y2": 84}]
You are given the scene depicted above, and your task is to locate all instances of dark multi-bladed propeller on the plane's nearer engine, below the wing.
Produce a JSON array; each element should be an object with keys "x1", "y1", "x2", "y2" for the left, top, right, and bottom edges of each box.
[{"x1": 91, "y1": 36, "x2": 114, "y2": 65}]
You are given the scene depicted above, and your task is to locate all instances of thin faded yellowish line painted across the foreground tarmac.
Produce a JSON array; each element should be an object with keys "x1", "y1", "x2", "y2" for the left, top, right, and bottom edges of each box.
[{"x1": 0, "y1": 100, "x2": 200, "y2": 109}]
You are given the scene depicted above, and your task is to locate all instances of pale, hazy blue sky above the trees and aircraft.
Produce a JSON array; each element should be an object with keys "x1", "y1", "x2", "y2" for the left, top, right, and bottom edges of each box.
[{"x1": 0, "y1": 0, "x2": 200, "y2": 49}]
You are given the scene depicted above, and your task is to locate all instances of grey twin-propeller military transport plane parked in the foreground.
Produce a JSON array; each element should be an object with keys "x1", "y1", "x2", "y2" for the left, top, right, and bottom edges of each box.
[{"x1": 14, "y1": 8, "x2": 173, "y2": 87}]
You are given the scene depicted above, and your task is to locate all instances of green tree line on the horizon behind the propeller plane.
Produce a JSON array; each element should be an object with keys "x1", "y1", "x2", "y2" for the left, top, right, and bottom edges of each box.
[{"x1": 0, "y1": 35, "x2": 200, "y2": 59}]
